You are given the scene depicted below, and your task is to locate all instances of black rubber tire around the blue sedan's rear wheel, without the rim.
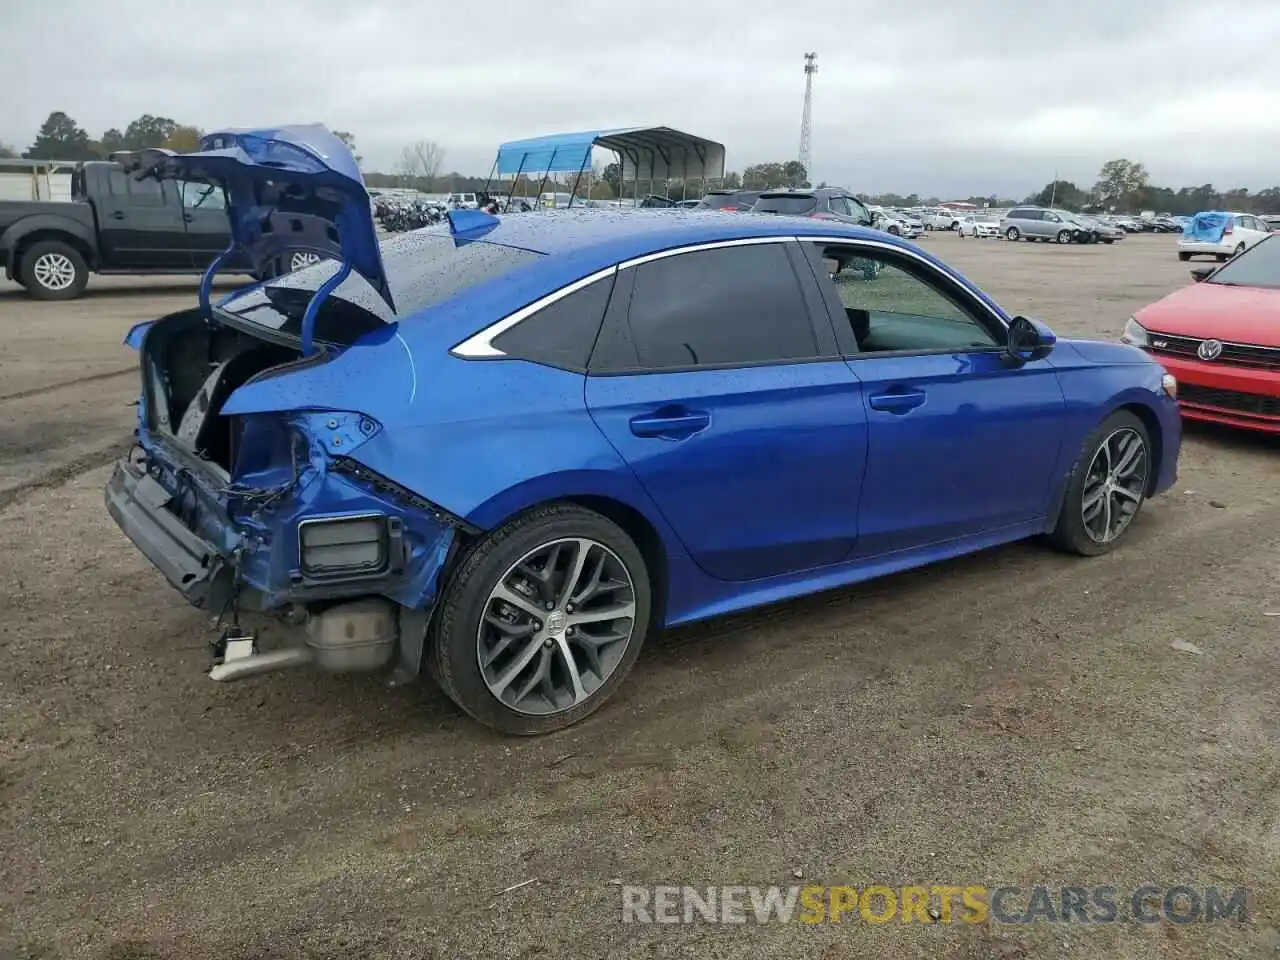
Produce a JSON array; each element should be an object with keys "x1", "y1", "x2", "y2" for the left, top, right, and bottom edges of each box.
[{"x1": 426, "y1": 503, "x2": 652, "y2": 736}]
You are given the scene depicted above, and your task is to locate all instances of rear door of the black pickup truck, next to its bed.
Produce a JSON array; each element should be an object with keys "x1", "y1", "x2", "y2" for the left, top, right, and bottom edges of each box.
[{"x1": 95, "y1": 169, "x2": 191, "y2": 270}]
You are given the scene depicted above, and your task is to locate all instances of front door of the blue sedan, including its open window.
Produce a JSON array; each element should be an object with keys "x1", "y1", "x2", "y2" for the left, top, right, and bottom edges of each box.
[{"x1": 804, "y1": 242, "x2": 1065, "y2": 557}]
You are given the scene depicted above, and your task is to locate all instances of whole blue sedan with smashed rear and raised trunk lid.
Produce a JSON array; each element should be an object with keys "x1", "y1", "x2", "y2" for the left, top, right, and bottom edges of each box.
[{"x1": 106, "y1": 128, "x2": 1181, "y2": 733}]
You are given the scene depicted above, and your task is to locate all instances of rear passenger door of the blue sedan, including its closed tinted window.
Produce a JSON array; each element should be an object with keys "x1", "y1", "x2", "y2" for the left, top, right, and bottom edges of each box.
[{"x1": 586, "y1": 237, "x2": 867, "y2": 580}]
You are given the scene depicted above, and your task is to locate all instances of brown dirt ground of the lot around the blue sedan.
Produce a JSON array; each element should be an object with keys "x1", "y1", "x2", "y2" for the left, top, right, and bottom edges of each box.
[{"x1": 0, "y1": 234, "x2": 1280, "y2": 960}]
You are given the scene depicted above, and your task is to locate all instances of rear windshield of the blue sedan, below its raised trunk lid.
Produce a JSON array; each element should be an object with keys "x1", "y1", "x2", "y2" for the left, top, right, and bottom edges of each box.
[{"x1": 227, "y1": 230, "x2": 541, "y2": 344}]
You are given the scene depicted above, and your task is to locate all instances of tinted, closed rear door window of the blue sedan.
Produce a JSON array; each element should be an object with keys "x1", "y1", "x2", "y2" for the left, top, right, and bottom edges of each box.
[{"x1": 614, "y1": 243, "x2": 819, "y2": 370}]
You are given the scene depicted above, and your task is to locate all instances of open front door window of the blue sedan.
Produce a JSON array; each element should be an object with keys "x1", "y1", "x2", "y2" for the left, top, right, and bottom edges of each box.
[{"x1": 818, "y1": 244, "x2": 1002, "y2": 353}]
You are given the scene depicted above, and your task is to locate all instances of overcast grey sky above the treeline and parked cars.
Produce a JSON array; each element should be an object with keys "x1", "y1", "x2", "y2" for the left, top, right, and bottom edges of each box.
[{"x1": 0, "y1": 0, "x2": 1280, "y2": 197}]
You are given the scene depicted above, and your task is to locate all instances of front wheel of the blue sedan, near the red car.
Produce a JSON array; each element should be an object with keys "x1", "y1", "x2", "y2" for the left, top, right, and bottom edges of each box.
[{"x1": 1051, "y1": 410, "x2": 1152, "y2": 557}]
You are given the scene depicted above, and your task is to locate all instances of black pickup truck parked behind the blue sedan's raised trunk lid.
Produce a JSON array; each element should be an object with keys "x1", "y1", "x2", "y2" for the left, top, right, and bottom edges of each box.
[{"x1": 0, "y1": 161, "x2": 335, "y2": 300}]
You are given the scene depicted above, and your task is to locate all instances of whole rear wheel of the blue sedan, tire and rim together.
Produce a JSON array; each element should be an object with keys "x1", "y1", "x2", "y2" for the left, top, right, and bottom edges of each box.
[{"x1": 429, "y1": 504, "x2": 650, "y2": 736}]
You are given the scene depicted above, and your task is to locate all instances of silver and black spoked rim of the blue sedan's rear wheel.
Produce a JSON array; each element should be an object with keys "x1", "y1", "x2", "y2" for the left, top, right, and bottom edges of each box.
[{"x1": 476, "y1": 538, "x2": 636, "y2": 716}]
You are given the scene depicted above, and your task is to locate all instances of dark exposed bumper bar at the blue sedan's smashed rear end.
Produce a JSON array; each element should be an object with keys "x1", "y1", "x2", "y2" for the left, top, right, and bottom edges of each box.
[{"x1": 105, "y1": 460, "x2": 232, "y2": 611}]
